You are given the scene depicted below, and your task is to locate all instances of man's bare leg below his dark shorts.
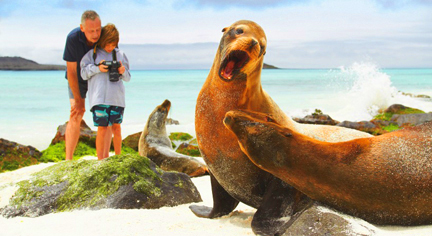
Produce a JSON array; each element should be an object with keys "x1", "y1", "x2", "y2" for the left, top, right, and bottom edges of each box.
[{"x1": 65, "y1": 99, "x2": 84, "y2": 160}]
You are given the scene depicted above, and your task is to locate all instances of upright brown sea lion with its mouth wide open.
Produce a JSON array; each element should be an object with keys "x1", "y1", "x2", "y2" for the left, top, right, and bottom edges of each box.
[{"x1": 191, "y1": 20, "x2": 369, "y2": 235}]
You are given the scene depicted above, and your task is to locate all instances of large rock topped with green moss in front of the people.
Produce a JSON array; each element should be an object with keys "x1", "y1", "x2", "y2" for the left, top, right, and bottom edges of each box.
[{"x1": 0, "y1": 154, "x2": 202, "y2": 217}]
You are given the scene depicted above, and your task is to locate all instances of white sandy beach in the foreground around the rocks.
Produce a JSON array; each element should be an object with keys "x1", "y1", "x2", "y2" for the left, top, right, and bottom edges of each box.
[{"x1": 0, "y1": 157, "x2": 432, "y2": 236}]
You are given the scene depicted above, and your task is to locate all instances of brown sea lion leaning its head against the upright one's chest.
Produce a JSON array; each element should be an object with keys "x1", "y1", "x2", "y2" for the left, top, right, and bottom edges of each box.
[{"x1": 224, "y1": 111, "x2": 432, "y2": 225}]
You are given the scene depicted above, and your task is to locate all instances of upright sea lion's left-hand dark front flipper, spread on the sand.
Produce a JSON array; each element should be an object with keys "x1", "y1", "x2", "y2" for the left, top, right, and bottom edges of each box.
[{"x1": 189, "y1": 173, "x2": 239, "y2": 218}]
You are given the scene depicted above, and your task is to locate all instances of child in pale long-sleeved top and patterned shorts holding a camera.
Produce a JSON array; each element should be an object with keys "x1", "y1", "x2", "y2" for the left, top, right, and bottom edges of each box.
[{"x1": 81, "y1": 24, "x2": 131, "y2": 160}]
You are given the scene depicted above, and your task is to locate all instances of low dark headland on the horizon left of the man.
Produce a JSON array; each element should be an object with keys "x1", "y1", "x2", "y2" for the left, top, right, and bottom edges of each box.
[{"x1": 0, "y1": 57, "x2": 66, "y2": 71}]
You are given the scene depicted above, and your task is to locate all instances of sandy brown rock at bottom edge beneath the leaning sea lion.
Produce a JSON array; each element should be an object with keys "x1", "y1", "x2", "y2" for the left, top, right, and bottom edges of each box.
[{"x1": 283, "y1": 203, "x2": 375, "y2": 236}]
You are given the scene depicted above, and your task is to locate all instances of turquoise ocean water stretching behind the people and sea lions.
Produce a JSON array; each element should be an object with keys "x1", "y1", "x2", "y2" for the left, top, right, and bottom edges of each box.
[{"x1": 0, "y1": 63, "x2": 432, "y2": 150}]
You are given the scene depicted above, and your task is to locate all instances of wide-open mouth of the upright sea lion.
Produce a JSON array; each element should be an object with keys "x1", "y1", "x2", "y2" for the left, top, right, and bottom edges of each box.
[{"x1": 219, "y1": 50, "x2": 249, "y2": 80}]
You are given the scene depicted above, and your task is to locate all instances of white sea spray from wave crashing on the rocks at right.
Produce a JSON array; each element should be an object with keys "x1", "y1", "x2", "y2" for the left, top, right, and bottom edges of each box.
[{"x1": 328, "y1": 62, "x2": 432, "y2": 121}]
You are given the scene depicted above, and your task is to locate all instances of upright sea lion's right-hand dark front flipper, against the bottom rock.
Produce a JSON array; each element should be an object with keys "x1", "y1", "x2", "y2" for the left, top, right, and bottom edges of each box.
[{"x1": 252, "y1": 178, "x2": 312, "y2": 235}]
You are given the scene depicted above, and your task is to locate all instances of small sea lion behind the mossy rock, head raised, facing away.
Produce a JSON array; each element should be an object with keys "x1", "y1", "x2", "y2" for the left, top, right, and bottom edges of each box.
[{"x1": 138, "y1": 100, "x2": 208, "y2": 177}]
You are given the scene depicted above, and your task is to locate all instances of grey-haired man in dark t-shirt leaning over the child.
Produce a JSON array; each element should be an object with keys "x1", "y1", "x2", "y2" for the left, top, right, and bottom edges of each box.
[{"x1": 63, "y1": 10, "x2": 102, "y2": 160}]
